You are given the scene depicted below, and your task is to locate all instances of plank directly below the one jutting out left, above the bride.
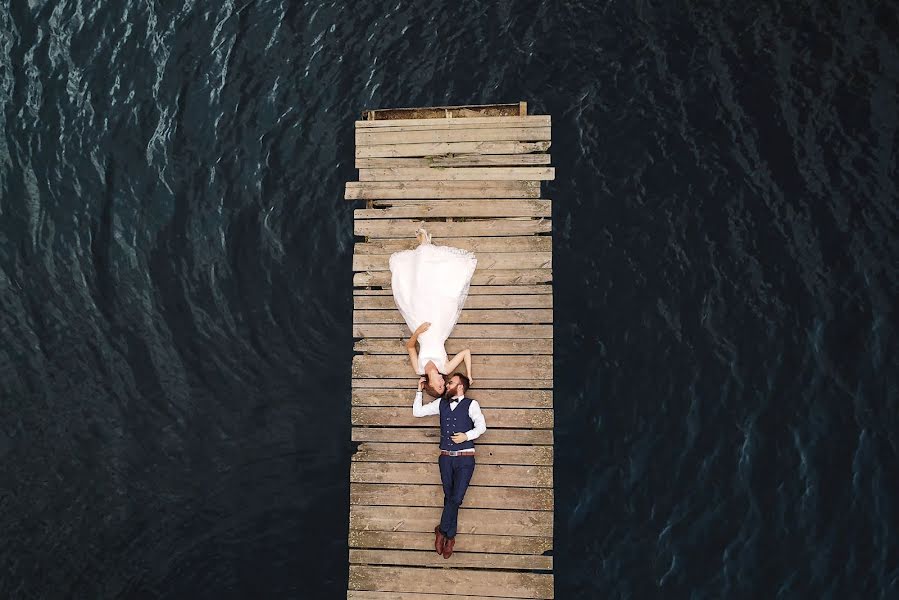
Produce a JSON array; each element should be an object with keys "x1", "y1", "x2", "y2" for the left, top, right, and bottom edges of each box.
[{"x1": 353, "y1": 199, "x2": 552, "y2": 219}]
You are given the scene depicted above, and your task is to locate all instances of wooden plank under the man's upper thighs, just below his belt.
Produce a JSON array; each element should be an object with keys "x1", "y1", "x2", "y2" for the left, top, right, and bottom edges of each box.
[{"x1": 350, "y1": 464, "x2": 553, "y2": 488}]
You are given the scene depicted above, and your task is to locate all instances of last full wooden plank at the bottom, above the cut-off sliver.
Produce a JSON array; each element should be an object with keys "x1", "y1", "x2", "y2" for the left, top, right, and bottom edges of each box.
[{"x1": 349, "y1": 565, "x2": 553, "y2": 599}]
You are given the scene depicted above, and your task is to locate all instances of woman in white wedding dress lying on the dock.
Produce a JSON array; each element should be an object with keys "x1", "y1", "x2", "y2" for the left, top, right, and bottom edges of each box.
[{"x1": 390, "y1": 228, "x2": 478, "y2": 398}]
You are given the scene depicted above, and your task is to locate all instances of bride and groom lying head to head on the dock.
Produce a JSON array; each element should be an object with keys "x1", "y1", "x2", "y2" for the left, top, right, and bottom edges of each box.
[{"x1": 390, "y1": 229, "x2": 487, "y2": 558}]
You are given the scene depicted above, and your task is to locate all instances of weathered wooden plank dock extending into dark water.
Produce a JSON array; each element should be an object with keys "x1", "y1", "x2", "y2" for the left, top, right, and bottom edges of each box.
[{"x1": 346, "y1": 102, "x2": 554, "y2": 600}]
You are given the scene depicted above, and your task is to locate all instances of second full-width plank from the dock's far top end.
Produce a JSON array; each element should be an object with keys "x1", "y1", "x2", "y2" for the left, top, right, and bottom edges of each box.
[{"x1": 354, "y1": 127, "x2": 552, "y2": 148}]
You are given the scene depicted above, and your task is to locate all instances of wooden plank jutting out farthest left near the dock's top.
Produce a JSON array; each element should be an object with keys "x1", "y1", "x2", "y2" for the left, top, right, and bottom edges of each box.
[{"x1": 344, "y1": 181, "x2": 540, "y2": 200}]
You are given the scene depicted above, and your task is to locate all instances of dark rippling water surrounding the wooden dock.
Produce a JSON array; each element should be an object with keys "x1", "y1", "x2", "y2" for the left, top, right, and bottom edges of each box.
[{"x1": 0, "y1": 0, "x2": 899, "y2": 599}]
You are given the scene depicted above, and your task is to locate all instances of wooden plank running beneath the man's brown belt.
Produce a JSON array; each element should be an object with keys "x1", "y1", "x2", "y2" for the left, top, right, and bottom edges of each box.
[{"x1": 351, "y1": 442, "x2": 553, "y2": 464}]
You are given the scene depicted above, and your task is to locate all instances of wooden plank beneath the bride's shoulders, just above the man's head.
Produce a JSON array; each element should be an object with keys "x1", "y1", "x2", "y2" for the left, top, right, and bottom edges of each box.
[{"x1": 353, "y1": 354, "x2": 553, "y2": 379}]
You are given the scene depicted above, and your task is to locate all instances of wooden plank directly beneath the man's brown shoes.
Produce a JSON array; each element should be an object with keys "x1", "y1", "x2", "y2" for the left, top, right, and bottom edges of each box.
[{"x1": 349, "y1": 529, "x2": 553, "y2": 558}]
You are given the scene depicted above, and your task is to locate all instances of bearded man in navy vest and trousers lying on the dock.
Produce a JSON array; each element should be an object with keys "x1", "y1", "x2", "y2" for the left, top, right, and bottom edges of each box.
[{"x1": 412, "y1": 373, "x2": 487, "y2": 558}]
